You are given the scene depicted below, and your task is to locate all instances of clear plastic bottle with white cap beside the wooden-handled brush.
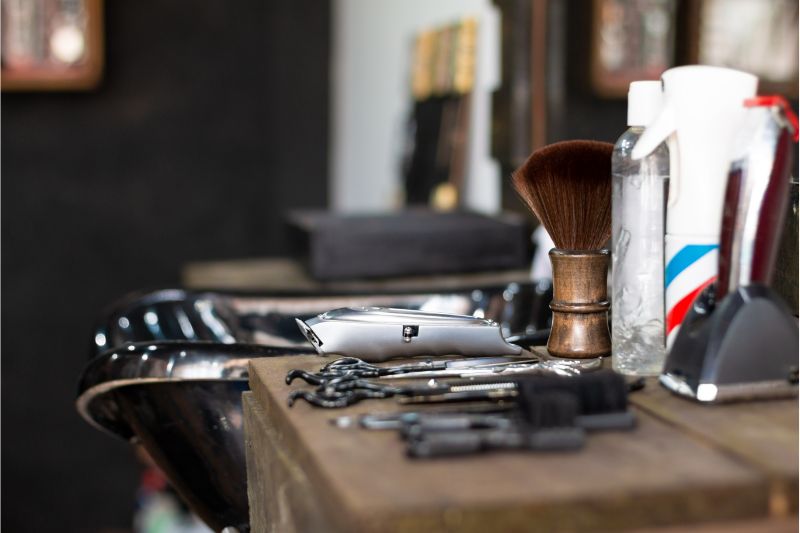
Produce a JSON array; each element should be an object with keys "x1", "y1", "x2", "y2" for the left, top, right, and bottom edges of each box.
[{"x1": 611, "y1": 81, "x2": 669, "y2": 376}]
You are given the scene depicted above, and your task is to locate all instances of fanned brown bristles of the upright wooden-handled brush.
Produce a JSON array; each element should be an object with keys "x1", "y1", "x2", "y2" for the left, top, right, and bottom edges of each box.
[{"x1": 513, "y1": 141, "x2": 614, "y2": 250}]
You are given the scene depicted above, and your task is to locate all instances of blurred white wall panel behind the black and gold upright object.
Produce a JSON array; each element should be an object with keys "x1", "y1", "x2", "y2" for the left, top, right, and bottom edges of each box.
[{"x1": 329, "y1": 0, "x2": 500, "y2": 213}]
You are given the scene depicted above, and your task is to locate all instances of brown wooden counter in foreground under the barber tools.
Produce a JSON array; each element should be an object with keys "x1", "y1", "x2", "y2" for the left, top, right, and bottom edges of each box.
[{"x1": 244, "y1": 356, "x2": 798, "y2": 533}]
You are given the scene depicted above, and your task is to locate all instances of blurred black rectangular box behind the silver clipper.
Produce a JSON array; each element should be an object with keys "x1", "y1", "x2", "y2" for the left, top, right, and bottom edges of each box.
[{"x1": 288, "y1": 209, "x2": 531, "y2": 281}]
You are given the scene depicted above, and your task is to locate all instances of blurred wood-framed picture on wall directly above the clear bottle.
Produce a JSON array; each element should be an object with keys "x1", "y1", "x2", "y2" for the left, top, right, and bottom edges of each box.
[{"x1": 590, "y1": 0, "x2": 677, "y2": 98}]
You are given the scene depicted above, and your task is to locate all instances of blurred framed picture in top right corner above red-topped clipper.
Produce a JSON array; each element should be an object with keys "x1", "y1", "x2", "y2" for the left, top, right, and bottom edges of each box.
[{"x1": 688, "y1": 0, "x2": 798, "y2": 98}]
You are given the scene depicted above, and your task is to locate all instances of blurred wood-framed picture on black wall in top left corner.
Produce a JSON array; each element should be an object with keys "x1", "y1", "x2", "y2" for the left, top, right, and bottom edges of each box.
[{"x1": 0, "y1": 0, "x2": 103, "y2": 91}]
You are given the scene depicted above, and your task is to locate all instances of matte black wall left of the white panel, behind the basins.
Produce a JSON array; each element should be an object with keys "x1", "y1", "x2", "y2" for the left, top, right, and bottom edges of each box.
[{"x1": 2, "y1": 0, "x2": 330, "y2": 532}]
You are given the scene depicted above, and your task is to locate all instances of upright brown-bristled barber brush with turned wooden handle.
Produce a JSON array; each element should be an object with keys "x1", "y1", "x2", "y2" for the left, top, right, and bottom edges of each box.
[{"x1": 513, "y1": 141, "x2": 614, "y2": 358}]
